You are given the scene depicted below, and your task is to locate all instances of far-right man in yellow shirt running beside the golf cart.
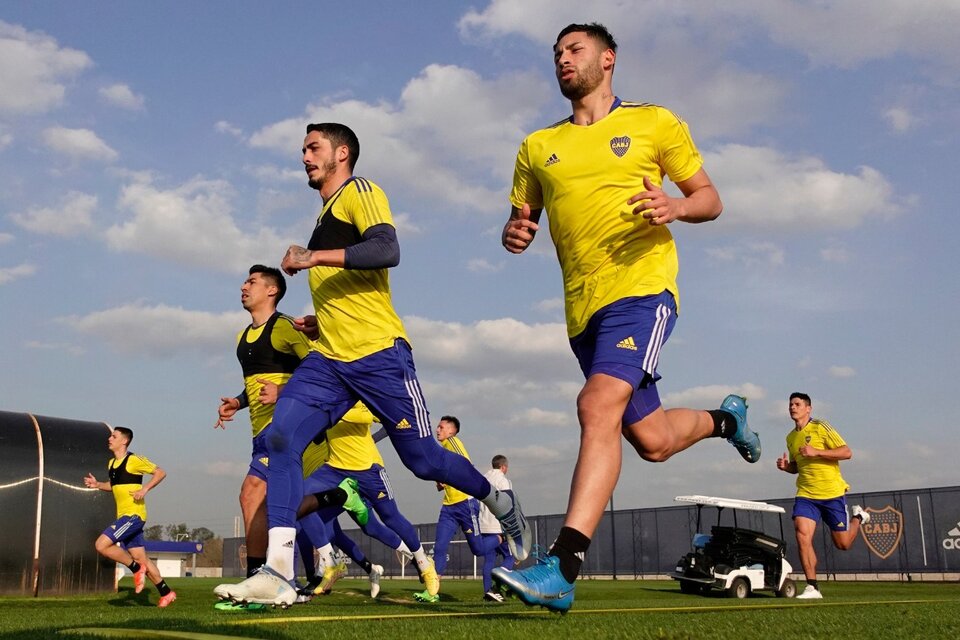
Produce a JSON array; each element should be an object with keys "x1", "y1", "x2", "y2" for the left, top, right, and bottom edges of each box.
[{"x1": 777, "y1": 392, "x2": 870, "y2": 600}]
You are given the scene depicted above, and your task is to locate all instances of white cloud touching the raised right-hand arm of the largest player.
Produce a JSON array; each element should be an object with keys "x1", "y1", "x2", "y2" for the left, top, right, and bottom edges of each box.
[{"x1": 704, "y1": 144, "x2": 909, "y2": 230}]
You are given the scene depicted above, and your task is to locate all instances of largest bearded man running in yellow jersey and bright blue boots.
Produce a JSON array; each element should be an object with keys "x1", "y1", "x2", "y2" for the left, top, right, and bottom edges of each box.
[{"x1": 493, "y1": 18, "x2": 760, "y2": 611}]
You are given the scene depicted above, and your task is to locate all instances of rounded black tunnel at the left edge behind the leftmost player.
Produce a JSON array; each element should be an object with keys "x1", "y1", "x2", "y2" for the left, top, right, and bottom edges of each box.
[{"x1": 0, "y1": 411, "x2": 117, "y2": 596}]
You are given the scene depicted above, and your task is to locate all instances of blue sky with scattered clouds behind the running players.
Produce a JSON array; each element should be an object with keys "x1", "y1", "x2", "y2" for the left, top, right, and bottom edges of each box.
[{"x1": 0, "y1": 0, "x2": 960, "y2": 535}]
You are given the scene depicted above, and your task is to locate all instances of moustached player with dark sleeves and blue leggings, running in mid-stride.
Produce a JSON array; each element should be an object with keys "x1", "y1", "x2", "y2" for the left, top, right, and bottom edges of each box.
[{"x1": 215, "y1": 123, "x2": 531, "y2": 606}]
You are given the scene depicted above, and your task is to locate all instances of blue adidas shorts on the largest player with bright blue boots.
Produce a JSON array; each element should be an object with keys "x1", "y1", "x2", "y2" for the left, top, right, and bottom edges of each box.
[{"x1": 570, "y1": 291, "x2": 677, "y2": 426}]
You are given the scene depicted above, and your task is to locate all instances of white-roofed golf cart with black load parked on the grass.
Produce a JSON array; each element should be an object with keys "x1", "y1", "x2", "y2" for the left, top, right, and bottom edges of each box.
[{"x1": 670, "y1": 496, "x2": 797, "y2": 598}]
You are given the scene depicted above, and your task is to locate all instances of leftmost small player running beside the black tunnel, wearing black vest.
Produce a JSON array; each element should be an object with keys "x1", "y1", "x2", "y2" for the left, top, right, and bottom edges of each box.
[{"x1": 83, "y1": 427, "x2": 177, "y2": 609}]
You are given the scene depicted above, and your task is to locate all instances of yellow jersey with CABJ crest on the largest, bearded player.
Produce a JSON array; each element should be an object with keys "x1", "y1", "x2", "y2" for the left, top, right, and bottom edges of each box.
[{"x1": 510, "y1": 98, "x2": 703, "y2": 337}]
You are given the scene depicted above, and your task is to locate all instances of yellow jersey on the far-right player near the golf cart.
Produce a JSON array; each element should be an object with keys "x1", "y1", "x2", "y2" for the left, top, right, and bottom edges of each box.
[{"x1": 787, "y1": 419, "x2": 850, "y2": 500}]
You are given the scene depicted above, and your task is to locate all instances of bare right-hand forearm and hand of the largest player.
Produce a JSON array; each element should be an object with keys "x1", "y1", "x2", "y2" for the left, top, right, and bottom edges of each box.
[{"x1": 627, "y1": 167, "x2": 723, "y2": 225}]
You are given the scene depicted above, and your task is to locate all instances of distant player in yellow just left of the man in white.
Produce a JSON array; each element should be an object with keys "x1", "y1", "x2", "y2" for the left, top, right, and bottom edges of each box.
[{"x1": 413, "y1": 416, "x2": 498, "y2": 603}]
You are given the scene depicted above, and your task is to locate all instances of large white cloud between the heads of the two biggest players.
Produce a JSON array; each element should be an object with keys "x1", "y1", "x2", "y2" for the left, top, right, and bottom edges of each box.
[{"x1": 250, "y1": 65, "x2": 549, "y2": 215}]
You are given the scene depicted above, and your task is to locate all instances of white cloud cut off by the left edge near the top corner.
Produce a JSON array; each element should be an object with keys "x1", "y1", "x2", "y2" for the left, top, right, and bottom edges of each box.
[{"x1": 0, "y1": 20, "x2": 93, "y2": 113}]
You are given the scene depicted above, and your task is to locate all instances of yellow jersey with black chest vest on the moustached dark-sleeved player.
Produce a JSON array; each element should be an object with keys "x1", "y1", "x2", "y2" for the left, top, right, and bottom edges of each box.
[{"x1": 307, "y1": 176, "x2": 409, "y2": 362}]
